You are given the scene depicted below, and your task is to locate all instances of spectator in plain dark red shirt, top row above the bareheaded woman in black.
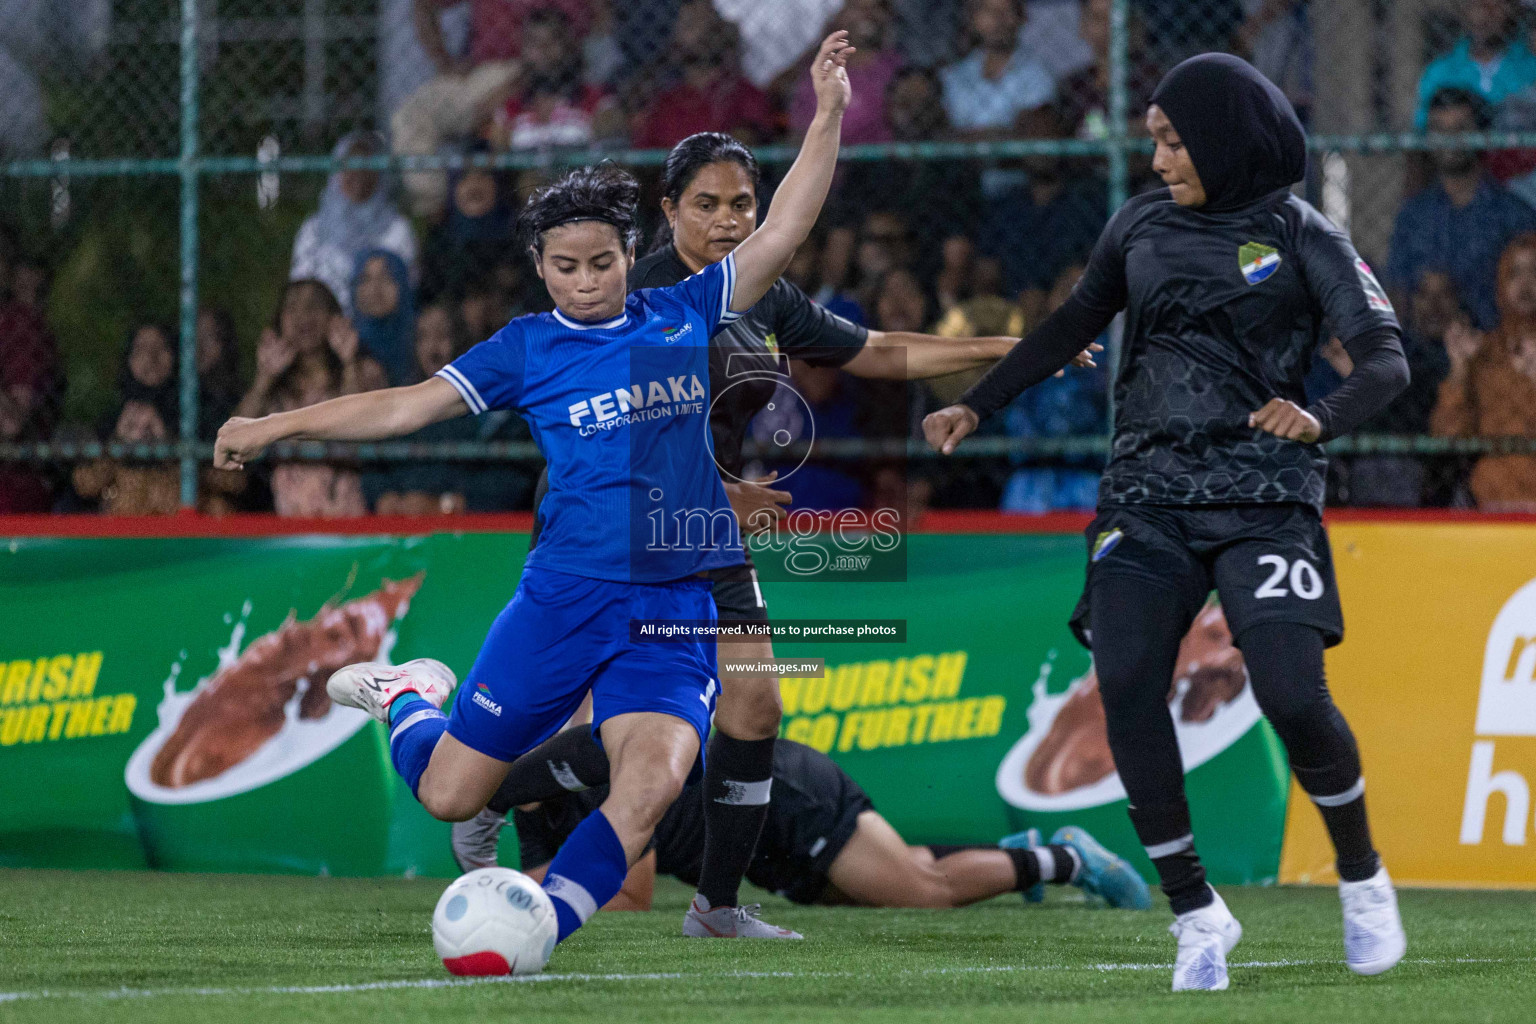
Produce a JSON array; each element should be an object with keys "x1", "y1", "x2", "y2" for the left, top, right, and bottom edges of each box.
[{"x1": 633, "y1": 0, "x2": 774, "y2": 149}]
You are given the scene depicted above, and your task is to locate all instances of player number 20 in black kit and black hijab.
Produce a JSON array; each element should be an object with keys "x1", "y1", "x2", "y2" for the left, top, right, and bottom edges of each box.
[{"x1": 923, "y1": 54, "x2": 1409, "y2": 990}]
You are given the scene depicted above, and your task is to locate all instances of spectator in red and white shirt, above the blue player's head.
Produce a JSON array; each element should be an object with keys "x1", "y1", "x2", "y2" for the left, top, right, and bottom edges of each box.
[{"x1": 492, "y1": 8, "x2": 624, "y2": 149}]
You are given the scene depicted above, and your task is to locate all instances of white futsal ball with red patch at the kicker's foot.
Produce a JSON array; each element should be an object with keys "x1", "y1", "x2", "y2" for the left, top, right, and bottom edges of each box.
[{"x1": 432, "y1": 867, "x2": 558, "y2": 975}]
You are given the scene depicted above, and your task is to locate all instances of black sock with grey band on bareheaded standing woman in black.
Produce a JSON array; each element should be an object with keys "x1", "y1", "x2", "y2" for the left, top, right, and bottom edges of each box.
[{"x1": 699, "y1": 729, "x2": 774, "y2": 907}]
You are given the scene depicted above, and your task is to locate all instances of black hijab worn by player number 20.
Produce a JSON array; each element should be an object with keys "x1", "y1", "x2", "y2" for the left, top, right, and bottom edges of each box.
[{"x1": 1152, "y1": 54, "x2": 1307, "y2": 213}]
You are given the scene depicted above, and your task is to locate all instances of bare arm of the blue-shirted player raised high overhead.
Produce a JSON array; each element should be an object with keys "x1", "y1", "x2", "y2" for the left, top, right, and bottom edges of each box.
[{"x1": 731, "y1": 31, "x2": 854, "y2": 313}]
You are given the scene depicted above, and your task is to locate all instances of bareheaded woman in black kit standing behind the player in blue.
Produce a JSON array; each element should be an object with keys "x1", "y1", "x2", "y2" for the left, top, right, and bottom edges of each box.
[{"x1": 453, "y1": 132, "x2": 1098, "y2": 938}]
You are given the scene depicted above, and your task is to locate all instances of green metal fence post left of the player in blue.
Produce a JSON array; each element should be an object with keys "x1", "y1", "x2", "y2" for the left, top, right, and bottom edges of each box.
[{"x1": 180, "y1": 0, "x2": 200, "y2": 508}]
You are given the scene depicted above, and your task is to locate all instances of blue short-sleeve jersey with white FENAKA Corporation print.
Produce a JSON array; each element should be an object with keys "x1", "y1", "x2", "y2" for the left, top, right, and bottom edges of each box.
[{"x1": 438, "y1": 256, "x2": 743, "y2": 583}]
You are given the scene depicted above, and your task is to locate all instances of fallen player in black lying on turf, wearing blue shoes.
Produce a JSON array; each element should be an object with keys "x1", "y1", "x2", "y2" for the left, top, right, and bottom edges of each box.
[{"x1": 453, "y1": 725, "x2": 1152, "y2": 914}]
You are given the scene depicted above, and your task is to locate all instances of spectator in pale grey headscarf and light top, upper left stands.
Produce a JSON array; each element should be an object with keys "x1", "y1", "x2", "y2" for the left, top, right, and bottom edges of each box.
[{"x1": 289, "y1": 130, "x2": 416, "y2": 315}]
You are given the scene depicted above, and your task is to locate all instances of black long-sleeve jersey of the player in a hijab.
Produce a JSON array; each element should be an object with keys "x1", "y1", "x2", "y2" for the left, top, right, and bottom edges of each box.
[{"x1": 960, "y1": 189, "x2": 1407, "y2": 508}]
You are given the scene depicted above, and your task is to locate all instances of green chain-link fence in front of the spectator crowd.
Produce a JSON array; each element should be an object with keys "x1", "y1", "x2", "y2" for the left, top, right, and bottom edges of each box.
[{"x1": 0, "y1": 0, "x2": 1536, "y2": 510}]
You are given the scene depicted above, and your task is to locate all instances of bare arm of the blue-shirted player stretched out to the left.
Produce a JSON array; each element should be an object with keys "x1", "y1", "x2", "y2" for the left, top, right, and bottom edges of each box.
[{"x1": 214, "y1": 376, "x2": 470, "y2": 470}]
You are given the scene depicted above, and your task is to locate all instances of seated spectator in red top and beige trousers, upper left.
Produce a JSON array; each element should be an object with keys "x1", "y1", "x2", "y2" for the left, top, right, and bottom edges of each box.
[{"x1": 390, "y1": 0, "x2": 594, "y2": 216}]
